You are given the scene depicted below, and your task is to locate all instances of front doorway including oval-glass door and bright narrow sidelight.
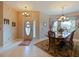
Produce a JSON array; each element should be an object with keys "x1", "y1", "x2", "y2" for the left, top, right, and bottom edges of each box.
[{"x1": 24, "y1": 20, "x2": 36, "y2": 40}]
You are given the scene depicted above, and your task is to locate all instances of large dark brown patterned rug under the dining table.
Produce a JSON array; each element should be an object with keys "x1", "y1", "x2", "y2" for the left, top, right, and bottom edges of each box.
[{"x1": 35, "y1": 39, "x2": 79, "y2": 57}]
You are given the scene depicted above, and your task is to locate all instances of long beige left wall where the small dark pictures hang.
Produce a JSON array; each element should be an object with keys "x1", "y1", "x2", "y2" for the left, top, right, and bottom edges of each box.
[{"x1": 3, "y1": 3, "x2": 17, "y2": 46}]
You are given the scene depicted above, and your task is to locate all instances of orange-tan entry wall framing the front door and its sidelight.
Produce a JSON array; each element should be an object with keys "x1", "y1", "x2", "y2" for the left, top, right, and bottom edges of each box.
[{"x1": 17, "y1": 11, "x2": 40, "y2": 39}]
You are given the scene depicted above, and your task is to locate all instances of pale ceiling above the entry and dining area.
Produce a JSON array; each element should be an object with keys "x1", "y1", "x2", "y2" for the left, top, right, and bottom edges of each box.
[{"x1": 4, "y1": 1, "x2": 79, "y2": 15}]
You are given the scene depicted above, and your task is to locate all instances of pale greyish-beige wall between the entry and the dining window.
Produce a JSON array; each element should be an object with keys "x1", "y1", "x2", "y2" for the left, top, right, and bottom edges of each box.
[{"x1": 39, "y1": 13, "x2": 49, "y2": 39}]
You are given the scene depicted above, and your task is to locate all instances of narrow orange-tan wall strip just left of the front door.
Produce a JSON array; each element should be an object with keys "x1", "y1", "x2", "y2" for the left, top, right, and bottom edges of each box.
[{"x1": 17, "y1": 12, "x2": 23, "y2": 39}]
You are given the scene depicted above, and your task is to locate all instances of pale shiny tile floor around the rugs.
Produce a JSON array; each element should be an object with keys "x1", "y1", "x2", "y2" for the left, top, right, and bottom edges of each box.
[{"x1": 0, "y1": 39, "x2": 51, "y2": 57}]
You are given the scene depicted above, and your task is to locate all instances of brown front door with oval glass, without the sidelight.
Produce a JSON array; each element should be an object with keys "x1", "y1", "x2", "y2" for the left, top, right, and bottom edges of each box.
[{"x1": 24, "y1": 20, "x2": 33, "y2": 40}]
